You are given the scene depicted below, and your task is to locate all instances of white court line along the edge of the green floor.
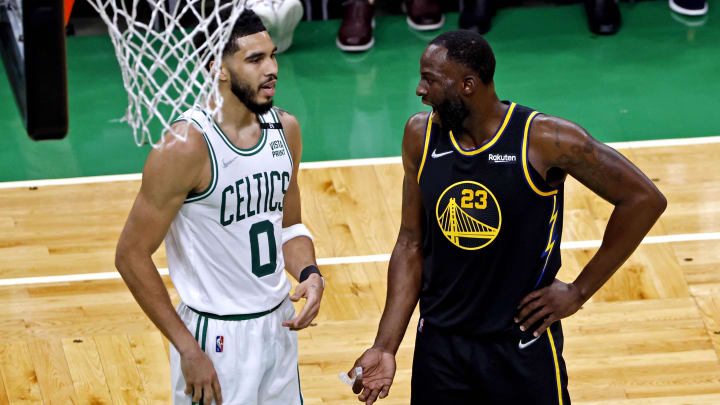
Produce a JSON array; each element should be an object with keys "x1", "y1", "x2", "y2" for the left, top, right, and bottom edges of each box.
[{"x1": 0, "y1": 136, "x2": 720, "y2": 190}]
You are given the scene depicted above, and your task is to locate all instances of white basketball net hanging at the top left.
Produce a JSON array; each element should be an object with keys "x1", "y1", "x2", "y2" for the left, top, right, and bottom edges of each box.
[{"x1": 88, "y1": 0, "x2": 245, "y2": 147}]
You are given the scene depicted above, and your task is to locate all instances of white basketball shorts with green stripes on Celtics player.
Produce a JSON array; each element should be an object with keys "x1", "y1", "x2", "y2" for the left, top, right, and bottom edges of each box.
[{"x1": 170, "y1": 298, "x2": 303, "y2": 405}]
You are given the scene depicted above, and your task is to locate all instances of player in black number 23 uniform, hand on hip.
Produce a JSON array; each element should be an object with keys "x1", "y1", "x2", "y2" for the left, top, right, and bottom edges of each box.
[{"x1": 349, "y1": 31, "x2": 667, "y2": 405}]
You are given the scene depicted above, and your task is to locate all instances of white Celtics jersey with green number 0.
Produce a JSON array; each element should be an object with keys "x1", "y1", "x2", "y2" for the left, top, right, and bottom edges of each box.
[{"x1": 165, "y1": 107, "x2": 293, "y2": 315}]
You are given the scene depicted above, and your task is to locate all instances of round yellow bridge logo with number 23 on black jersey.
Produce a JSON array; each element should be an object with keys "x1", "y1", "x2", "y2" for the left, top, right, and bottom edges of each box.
[{"x1": 435, "y1": 181, "x2": 502, "y2": 250}]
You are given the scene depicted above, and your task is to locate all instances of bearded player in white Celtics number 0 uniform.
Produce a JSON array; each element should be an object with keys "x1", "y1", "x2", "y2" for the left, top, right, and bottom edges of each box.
[{"x1": 116, "y1": 10, "x2": 324, "y2": 405}]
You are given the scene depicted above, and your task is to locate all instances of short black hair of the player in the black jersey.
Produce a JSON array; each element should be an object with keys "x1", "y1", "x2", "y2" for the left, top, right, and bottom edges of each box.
[{"x1": 430, "y1": 30, "x2": 495, "y2": 85}]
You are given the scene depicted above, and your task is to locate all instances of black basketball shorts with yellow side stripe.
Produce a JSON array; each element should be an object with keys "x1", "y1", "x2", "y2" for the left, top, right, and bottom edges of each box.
[{"x1": 411, "y1": 320, "x2": 570, "y2": 405}]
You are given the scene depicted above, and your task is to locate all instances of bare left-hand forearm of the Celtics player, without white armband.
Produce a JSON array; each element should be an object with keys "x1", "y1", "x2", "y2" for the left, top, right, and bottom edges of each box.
[{"x1": 115, "y1": 254, "x2": 199, "y2": 354}]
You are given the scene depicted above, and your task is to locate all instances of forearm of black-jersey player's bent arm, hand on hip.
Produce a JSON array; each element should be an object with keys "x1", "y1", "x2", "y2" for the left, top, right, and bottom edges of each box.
[{"x1": 573, "y1": 193, "x2": 667, "y2": 302}]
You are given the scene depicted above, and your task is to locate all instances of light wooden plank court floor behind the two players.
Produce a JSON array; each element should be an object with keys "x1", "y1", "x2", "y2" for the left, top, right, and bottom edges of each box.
[{"x1": 0, "y1": 143, "x2": 720, "y2": 405}]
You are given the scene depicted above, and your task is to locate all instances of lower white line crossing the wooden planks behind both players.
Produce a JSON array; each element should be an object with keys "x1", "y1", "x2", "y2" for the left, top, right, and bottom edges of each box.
[{"x1": 0, "y1": 232, "x2": 720, "y2": 287}]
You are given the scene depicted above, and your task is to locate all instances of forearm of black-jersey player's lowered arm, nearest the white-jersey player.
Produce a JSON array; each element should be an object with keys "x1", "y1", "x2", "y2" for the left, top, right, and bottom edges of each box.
[{"x1": 373, "y1": 238, "x2": 423, "y2": 354}]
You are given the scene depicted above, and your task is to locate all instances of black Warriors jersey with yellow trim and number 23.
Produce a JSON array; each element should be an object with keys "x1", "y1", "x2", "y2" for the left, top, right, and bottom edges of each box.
[{"x1": 418, "y1": 102, "x2": 563, "y2": 335}]
